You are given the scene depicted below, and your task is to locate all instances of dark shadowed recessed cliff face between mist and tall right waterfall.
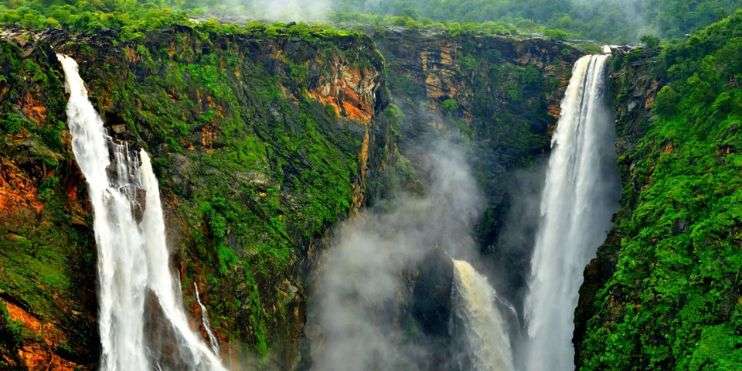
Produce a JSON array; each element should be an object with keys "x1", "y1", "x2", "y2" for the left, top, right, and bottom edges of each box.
[{"x1": 371, "y1": 28, "x2": 582, "y2": 302}]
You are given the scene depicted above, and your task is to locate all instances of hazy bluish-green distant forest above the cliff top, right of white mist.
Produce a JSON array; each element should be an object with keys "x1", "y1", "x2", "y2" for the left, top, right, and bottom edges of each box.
[{"x1": 339, "y1": 0, "x2": 742, "y2": 42}]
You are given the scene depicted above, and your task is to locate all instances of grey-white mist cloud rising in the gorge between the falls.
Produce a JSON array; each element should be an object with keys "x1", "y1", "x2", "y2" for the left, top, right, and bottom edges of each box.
[{"x1": 307, "y1": 142, "x2": 482, "y2": 370}]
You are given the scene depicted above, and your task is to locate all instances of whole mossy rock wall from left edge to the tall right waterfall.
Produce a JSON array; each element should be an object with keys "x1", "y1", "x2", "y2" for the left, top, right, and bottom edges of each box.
[{"x1": 0, "y1": 24, "x2": 580, "y2": 369}]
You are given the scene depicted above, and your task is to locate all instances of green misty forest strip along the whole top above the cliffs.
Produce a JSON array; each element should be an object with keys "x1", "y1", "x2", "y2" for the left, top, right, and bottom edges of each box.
[{"x1": 5, "y1": 0, "x2": 742, "y2": 42}]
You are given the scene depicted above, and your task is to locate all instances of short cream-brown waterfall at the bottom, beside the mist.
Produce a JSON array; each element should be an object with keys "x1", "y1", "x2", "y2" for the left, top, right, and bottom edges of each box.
[{"x1": 453, "y1": 260, "x2": 514, "y2": 371}]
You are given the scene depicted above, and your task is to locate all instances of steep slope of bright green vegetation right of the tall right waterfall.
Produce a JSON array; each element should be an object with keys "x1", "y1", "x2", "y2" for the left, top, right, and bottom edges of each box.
[{"x1": 578, "y1": 12, "x2": 742, "y2": 370}]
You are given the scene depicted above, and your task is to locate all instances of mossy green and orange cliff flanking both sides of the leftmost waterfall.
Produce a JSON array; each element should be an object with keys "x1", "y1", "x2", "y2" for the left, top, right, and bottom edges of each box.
[{"x1": 0, "y1": 27, "x2": 383, "y2": 369}]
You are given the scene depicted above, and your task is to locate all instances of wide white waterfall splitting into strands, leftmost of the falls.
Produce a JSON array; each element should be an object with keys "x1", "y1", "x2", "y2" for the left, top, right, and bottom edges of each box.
[{"x1": 57, "y1": 54, "x2": 224, "y2": 370}]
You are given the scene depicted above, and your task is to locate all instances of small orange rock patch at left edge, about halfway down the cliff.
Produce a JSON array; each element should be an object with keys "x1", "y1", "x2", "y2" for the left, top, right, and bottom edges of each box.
[{"x1": 0, "y1": 159, "x2": 44, "y2": 215}]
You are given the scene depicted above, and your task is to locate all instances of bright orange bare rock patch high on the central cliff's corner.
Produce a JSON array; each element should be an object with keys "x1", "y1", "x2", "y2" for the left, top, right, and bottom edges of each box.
[{"x1": 309, "y1": 60, "x2": 379, "y2": 124}]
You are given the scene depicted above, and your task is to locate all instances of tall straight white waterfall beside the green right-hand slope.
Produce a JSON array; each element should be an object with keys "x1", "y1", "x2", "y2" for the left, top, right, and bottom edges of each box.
[{"x1": 524, "y1": 55, "x2": 618, "y2": 370}]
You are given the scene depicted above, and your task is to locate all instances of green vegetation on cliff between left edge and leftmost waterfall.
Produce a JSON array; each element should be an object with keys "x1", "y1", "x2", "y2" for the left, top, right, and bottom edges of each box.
[{"x1": 0, "y1": 37, "x2": 97, "y2": 362}]
